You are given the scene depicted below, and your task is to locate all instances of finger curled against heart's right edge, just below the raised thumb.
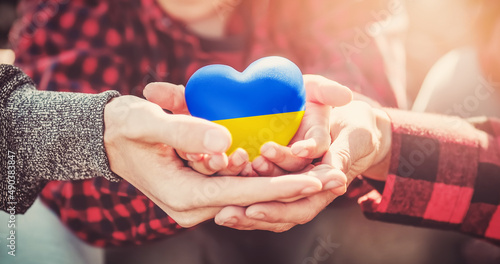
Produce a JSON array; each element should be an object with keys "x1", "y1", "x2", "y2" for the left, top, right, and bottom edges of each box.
[{"x1": 291, "y1": 103, "x2": 331, "y2": 159}]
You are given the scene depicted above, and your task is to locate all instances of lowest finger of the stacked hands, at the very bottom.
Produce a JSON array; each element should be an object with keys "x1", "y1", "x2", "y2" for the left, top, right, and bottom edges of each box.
[{"x1": 215, "y1": 206, "x2": 295, "y2": 233}]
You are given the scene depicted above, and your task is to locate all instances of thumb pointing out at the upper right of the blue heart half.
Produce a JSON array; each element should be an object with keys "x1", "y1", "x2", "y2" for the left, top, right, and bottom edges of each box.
[{"x1": 304, "y1": 74, "x2": 352, "y2": 107}]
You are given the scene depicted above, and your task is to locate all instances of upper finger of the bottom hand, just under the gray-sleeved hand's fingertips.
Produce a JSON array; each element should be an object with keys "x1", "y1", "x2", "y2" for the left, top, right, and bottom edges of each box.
[{"x1": 245, "y1": 191, "x2": 337, "y2": 224}]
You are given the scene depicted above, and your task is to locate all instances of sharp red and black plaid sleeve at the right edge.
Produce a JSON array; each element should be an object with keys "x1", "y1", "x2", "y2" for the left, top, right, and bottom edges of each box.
[{"x1": 360, "y1": 110, "x2": 500, "y2": 245}]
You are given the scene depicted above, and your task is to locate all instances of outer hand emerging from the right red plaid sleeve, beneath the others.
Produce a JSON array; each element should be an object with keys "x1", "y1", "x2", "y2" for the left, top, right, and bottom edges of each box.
[{"x1": 215, "y1": 101, "x2": 391, "y2": 232}]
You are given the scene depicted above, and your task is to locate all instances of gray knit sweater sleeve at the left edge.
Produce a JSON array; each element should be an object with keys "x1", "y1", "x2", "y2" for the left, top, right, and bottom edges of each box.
[{"x1": 0, "y1": 64, "x2": 119, "y2": 214}]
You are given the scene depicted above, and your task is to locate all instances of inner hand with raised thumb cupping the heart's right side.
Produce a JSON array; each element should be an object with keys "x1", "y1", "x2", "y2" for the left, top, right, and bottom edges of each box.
[{"x1": 250, "y1": 75, "x2": 353, "y2": 176}]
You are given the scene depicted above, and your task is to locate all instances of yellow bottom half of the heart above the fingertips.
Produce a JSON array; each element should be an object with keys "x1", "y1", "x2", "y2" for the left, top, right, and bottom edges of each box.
[{"x1": 213, "y1": 111, "x2": 304, "y2": 161}]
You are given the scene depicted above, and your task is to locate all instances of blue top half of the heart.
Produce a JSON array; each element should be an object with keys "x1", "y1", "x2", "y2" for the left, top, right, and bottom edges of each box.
[{"x1": 185, "y1": 56, "x2": 306, "y2": 121}]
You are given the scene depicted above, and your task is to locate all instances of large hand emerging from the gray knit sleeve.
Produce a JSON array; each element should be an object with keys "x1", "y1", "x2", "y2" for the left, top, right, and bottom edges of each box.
[{"x1": 104, "y1": 96, "x2": 335, "y2": 227}]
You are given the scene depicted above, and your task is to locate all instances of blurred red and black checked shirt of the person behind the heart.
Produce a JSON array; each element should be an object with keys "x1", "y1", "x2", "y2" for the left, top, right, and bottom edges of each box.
[{"x1": 10, "y1": 0, "x2": 396, "y2": 246}]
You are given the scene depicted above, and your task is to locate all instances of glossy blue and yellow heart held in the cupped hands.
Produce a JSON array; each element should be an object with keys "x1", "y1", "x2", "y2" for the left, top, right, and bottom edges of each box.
[{"x1": 185, "y1": 56, "x2": 306, "y2": 161}]
